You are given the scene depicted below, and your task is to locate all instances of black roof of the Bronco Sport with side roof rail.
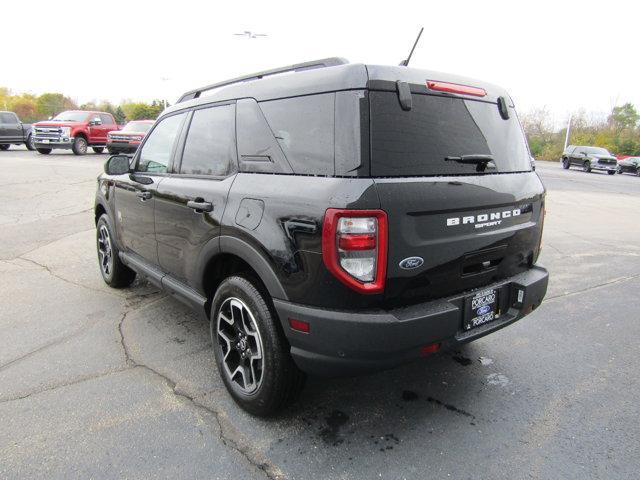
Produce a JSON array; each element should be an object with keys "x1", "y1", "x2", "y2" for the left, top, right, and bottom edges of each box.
[{"x1": 165, "y1": 58, "x2": 512, "y2": 113}]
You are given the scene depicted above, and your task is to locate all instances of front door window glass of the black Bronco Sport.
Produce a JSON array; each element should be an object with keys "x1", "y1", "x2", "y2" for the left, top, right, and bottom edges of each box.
[{"x1": 136, "y1": 113, "x2": 186, "y2": 173}]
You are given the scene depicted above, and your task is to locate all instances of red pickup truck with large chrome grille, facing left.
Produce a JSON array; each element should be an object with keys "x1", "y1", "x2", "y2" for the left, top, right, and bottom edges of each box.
[{"x1": 32, "y1": 110, "x2": 120, "y2": 155}]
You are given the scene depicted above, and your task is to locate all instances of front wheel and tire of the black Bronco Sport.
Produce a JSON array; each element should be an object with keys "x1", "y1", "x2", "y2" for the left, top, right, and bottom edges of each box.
[{"x1": 96, "y1": 214, "x2": 136, "y2": 288}]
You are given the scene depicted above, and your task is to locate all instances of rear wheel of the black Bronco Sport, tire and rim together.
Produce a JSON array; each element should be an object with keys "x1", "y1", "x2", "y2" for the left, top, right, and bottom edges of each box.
[{"x1": 210, "y1": 276, "x2": 305, "y2": 417}]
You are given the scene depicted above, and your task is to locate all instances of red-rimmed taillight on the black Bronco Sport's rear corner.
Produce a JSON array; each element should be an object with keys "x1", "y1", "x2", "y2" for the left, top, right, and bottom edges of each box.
[{"x1": 322, "y1": 208, "x2": 387, "y2": 293}]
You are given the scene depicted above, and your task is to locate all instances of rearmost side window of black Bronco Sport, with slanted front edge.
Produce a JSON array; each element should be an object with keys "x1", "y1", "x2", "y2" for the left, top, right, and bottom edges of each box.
[{"x1": 260, "y1": 93, "x2": 335, "y2": 175}]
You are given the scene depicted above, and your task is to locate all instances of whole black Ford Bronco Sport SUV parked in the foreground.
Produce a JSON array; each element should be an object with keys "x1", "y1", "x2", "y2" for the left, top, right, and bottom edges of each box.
[{"x1": 95, "y1": 59, "x2": 548, "y2": 415}]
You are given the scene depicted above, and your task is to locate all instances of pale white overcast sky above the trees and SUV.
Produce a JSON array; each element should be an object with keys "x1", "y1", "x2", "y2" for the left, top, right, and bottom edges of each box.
[{"x1": 0, "y1": 0, "x2": 640, "y2": 122}]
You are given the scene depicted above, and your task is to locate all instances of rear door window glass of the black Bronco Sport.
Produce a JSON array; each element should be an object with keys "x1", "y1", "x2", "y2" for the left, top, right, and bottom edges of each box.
[{"x1": 180, "y1": 105, "x2": 236, "y2": 175}]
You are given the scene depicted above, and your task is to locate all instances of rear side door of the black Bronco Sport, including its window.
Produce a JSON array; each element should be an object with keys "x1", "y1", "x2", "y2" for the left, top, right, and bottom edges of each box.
[{"x1": 155, "y1": 103, "x2": 237, "y2": 287}]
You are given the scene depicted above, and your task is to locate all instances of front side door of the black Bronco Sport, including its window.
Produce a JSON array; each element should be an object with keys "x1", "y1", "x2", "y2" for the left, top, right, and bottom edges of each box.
[{"x1": 115, "y1": 112, "x2": 187, "y2": 266}]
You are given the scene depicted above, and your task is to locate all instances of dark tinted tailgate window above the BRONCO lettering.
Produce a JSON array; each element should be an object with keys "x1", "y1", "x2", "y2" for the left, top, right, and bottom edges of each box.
[{"x1": 370, "y1": 91, "x2": 531, "y2": 177}]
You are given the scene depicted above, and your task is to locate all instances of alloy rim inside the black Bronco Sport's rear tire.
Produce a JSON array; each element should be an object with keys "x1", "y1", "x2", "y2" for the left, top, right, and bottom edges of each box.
[{"x1": 216, "y1": 297, "x2": 264, "y2": 395}]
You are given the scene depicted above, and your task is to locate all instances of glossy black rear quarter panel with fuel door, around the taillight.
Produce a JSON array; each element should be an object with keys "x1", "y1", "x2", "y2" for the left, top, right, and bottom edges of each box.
[{"x1": 222, "y1": 173, "x2": 380, "y2": 309}]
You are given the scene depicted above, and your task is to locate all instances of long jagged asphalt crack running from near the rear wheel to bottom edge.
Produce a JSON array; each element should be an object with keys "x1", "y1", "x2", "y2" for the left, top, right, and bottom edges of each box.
[{"x1": 118, "y1": 310, "x2": 284, "y2": 480}]
